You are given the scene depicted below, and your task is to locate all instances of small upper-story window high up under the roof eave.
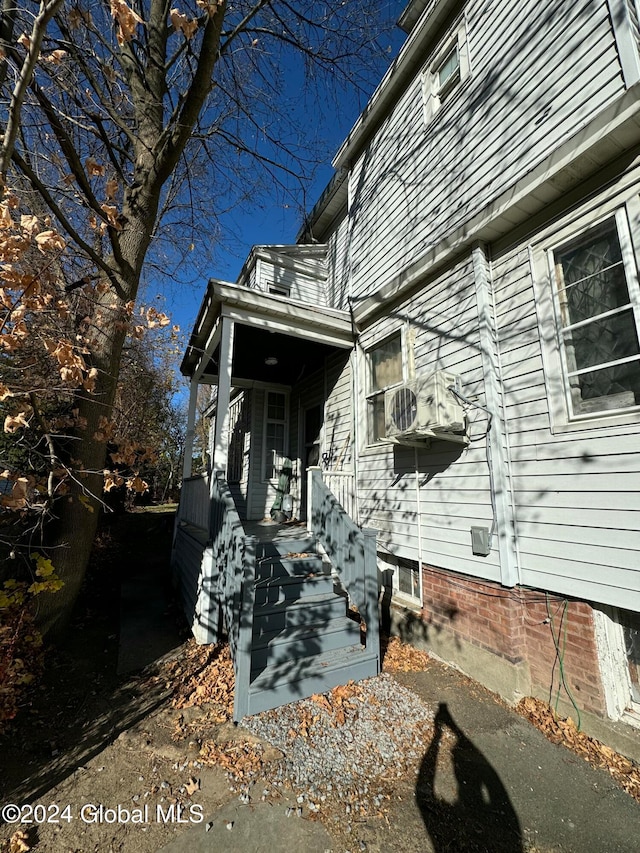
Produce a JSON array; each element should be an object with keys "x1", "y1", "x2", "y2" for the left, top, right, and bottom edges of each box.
[{"x1": 422, "y1": 20, "x2": 470, "y2": 122}]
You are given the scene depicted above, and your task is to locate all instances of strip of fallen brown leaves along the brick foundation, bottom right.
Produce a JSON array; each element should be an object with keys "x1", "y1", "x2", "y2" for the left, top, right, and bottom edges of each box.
[{"x1": 516, "y1": 696, "x2": 640, "y2": 802}]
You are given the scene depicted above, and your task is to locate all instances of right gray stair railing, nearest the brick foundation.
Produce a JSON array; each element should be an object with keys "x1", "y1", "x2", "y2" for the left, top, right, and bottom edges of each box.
[{"x1": 307, "y1": 467, "x2": 380, "y2": 666}]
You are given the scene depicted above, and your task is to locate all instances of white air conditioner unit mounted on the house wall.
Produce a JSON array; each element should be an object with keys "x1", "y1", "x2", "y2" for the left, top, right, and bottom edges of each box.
[{"x1": 384, "y1": 370, "x2": 466, "y2": 442}]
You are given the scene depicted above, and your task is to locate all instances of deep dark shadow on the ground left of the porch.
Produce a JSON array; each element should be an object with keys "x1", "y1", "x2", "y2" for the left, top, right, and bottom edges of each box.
[{"x1": 0, "y1": 507, "x2": 187, "y2": 802}]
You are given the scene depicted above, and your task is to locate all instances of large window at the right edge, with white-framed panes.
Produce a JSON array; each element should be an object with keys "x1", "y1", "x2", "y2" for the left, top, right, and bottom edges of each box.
[{"x1": 550, "y1": 211, "x2": 640, "y2": 418}]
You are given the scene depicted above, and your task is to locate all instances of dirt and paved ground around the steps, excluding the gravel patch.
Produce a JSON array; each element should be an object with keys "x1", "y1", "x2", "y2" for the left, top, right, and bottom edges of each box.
[{"x1": 0, "y1": 508, "x2": 640, "y2": 853}]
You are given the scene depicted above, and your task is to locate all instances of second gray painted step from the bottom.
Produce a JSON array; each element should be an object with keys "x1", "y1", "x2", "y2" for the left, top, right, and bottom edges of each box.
[{"x1": 251, "y1": 616, "x2": 360, "y2": 677}]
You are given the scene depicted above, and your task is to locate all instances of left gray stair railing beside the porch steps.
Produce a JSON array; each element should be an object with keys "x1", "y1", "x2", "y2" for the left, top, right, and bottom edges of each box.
[{"x1": 209, "y1": 471, "x2": 256, "y2": 720}]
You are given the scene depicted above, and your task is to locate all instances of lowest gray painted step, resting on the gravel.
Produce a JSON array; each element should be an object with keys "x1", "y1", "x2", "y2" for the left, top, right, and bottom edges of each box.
[{"x1": 242, "y1": 645, "x2": 378, "y2": 714}]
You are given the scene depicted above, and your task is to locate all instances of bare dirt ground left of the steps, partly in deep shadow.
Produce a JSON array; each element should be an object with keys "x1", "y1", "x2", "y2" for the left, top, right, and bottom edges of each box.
[{"x1": 0, "y1": 511, "x2": 231, "y2": 853}]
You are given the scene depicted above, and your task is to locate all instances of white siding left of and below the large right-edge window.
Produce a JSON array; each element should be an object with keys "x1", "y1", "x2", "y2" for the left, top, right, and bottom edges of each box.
[{"x1": 493, "y1": 188, "x2": 640, "y2": 610}]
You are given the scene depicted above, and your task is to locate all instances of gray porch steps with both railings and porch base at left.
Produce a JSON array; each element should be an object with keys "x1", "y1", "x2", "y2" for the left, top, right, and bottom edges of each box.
[{"x1": 172, "y1": 468, "x2": 380, "y2": 721}]
